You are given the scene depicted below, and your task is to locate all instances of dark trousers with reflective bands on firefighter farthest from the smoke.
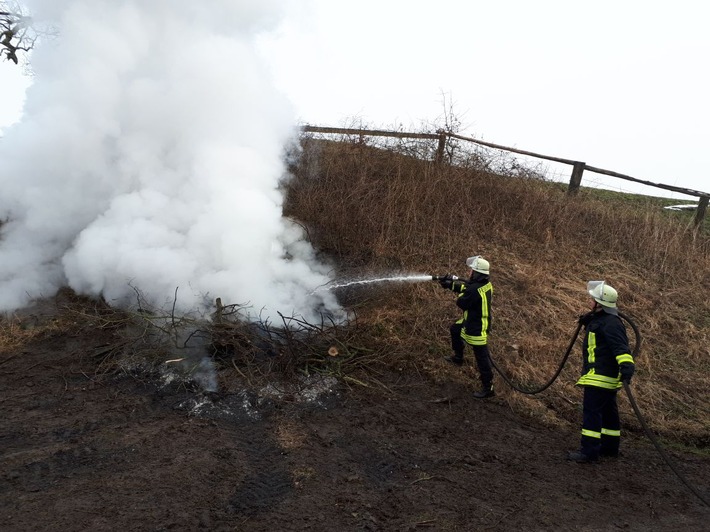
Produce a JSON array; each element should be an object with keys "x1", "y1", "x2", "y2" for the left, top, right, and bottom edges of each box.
[{"x1": 582, "y1": 386, "x2": 621, "y2": 459}]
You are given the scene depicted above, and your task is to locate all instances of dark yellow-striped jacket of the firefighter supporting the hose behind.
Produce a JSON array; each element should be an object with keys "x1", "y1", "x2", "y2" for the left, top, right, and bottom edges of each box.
[{"x1": 577, "y1": 310, "x2": 634, "y2": 390}]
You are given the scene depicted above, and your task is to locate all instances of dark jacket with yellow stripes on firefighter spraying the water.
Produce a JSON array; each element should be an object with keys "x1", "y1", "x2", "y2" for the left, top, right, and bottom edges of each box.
[{"x1": 451, "y1": 272, "x2": 493, "y2": 345}]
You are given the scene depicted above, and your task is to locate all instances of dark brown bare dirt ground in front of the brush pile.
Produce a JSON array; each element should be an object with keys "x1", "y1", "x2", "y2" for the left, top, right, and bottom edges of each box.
[{"x1": 0, "y1": 298, "x2": 710, "y2": 531}]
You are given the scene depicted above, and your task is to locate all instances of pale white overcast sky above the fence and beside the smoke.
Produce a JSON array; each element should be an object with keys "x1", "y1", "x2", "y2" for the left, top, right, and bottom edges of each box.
[{"x1": 5, "y1": 0, "x2": 710, "y2": 199}]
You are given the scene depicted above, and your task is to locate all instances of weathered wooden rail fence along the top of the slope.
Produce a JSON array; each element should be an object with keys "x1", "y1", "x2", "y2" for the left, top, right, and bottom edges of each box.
[{"x1": 302, "y1": 126, "x2": 710, "y2": 230}]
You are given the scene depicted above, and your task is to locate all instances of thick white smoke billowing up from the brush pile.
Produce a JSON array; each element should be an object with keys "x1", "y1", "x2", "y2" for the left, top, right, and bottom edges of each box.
[{"x1": 0, "y1": 0, "x2": 339, "y2": 319}]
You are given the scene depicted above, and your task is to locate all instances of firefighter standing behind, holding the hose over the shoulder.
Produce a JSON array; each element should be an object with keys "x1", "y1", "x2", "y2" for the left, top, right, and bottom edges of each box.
[{"x1": 567, "y1": 281, "x2": 635, "y2": 463}]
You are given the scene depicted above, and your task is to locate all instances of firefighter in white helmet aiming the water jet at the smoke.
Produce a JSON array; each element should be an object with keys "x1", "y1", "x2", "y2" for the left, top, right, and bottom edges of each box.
[{"x1": 439, "y1": 255, "x2": 494, "y2": 399}]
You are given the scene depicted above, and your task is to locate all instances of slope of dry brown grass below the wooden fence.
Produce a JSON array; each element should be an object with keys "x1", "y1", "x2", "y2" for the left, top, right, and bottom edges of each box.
[{"x1": 285, "y1": 139, "x2": 710, "y2": 447}]
